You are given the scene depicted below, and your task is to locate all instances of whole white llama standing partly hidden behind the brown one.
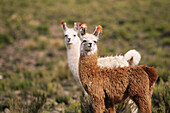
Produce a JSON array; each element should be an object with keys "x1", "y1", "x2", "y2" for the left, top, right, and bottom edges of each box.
[{"x1": 61, "y1": 21, "x2": 141, "y2": 113}]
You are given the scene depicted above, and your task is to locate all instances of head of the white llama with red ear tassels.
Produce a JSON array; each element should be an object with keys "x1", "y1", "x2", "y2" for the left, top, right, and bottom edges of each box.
[{"x1": 61, "y1": 21, "x2": 80, "y2": 46}]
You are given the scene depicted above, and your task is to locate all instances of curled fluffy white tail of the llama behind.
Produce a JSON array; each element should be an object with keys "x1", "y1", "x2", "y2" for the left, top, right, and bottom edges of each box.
[{"x1": 124, "y1": 49, "x2": 141, "y2": 65}]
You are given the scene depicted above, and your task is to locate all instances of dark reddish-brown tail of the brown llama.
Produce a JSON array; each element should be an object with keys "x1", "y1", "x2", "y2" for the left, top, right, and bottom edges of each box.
[{"x1": 142, "y1": 66, "x2": 158, "y2": 96}]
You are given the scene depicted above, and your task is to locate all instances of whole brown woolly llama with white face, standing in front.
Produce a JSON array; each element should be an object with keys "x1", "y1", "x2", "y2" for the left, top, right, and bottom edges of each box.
[{"x1": 79, "y1": 26, "x2": 158, "y2": 113}]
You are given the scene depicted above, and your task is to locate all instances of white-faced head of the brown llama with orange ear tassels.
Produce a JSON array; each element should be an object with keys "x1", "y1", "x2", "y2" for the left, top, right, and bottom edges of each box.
[{"x1": 80, "y1": 24, "x2": 102, "y2": 55}]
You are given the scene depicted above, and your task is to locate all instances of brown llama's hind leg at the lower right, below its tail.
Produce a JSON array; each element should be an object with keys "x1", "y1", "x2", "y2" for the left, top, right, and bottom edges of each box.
[{"x1": 133, "y1": 95, "x2": 151, "y2": 113}]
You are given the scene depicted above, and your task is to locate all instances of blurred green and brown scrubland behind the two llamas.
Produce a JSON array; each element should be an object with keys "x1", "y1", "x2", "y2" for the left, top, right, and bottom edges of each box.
[{"x1": 0, "y1": 0, "x2": 170, "y2": 113}]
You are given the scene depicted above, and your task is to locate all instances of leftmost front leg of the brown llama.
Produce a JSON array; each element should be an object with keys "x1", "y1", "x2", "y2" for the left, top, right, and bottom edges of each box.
[{"x1": 92, "y1": 98, "x2": 105, "y2": 113}]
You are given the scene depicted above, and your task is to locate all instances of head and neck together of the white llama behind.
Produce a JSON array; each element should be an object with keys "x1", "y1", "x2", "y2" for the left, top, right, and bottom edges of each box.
[{"x1": 61, "y1": 21, "x2": 81, "y2": 83}]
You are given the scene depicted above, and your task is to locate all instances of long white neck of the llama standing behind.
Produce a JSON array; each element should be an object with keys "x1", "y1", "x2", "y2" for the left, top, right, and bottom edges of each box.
[{"x1": 67, "y1": 40, "x2": 81, "y2": 81}]
